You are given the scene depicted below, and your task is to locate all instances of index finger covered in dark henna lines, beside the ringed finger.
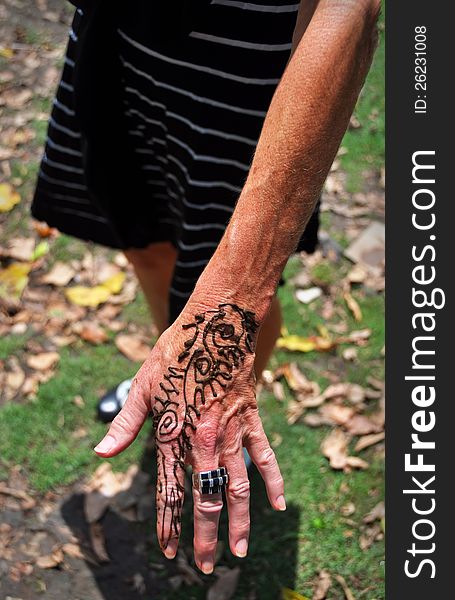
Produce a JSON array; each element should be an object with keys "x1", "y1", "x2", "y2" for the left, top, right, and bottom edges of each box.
[{"x1": 156, "y1": 439, "x2": 185, "y2": 558}]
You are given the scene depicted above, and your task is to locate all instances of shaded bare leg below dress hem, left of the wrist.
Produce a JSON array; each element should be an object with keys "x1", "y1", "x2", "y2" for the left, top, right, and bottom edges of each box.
[{"x1": 125, "y1": 242, "x2": 177, "y2": 334}]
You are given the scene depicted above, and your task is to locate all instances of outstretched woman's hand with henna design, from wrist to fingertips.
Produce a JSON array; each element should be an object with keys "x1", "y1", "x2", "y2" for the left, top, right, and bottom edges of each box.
[{"x1": 95, "y1": 304, "x2": 286, "y2": 573}]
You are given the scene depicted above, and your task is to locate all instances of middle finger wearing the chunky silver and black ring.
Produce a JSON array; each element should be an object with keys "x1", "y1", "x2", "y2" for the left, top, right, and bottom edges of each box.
[{"x1": 193, "y1": 444, "x2": 223, "y2": 575}]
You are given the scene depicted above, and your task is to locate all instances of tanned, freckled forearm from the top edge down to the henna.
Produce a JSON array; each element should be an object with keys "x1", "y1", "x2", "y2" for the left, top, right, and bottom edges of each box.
[{"x1": 190, "y1": 0, "x2": 377, "y2": 321}]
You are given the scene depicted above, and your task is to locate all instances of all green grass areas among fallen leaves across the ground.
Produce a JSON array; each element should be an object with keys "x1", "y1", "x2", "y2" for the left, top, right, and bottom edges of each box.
[{"x1": 0, "y1": 10, "x2": 384, "y2": 600}]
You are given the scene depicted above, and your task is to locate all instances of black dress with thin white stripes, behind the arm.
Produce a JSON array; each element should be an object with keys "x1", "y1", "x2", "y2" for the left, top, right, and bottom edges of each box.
[{"x1": 32, "y1": 0, "x2": 317, "y2": 318}]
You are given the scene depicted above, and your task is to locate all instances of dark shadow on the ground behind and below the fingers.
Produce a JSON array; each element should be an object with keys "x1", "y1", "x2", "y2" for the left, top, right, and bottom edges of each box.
[{"x1": 62, "y1": 436, "x2": 299, "y2": 600}]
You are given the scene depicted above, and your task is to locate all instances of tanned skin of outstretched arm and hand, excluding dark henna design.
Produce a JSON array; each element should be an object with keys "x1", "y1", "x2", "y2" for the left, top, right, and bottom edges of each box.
[{"x1": 96, "y1": 0, "x2": 380, "y2": 573}]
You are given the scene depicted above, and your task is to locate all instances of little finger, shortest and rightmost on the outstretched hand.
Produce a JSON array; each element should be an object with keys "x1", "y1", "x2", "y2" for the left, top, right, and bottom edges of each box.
[{"x1": 244, "y1": 412, "x2": 286, "y2": 510}]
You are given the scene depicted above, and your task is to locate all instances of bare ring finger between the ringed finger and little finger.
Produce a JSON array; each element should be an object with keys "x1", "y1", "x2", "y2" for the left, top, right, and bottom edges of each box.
[{"x1": 220, "y1": 442, "x2": 250, "y2": 558}]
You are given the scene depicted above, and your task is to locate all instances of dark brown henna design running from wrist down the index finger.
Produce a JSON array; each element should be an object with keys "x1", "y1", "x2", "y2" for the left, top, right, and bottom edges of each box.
[{"x1": 152, "y1": 304, "x2": 259, "y2": 549}]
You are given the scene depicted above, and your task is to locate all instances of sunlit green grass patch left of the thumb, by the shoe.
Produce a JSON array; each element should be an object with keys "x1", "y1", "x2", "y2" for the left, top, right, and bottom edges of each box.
[{"x1": 0, "y1": 336, "x2": 147, "y2": 492}]
